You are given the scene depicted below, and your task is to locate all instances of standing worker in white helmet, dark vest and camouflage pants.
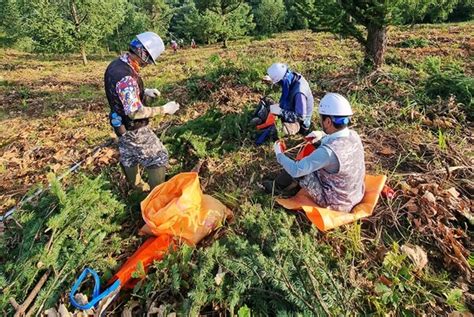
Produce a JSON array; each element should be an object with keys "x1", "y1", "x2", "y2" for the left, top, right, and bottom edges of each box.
[{"x1": 104, "y1": 32, "x2": 179, "y2": 190}]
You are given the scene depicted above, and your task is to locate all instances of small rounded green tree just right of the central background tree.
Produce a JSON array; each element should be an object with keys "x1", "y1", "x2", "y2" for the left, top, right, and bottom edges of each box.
[{"x1": 254, "y1": 0, "x2": 285, "y2": 34}]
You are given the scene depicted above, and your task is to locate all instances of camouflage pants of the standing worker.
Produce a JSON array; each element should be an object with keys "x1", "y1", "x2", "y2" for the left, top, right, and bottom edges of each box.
[{"x1": 119, "y1": 126, "x2": 168, "y2": 168}]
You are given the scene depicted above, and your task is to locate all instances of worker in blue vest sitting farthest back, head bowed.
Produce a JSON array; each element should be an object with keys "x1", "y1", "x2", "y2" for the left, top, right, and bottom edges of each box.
[{"x1": 251, "y1": 63, "x2": 314, "y2": 135}]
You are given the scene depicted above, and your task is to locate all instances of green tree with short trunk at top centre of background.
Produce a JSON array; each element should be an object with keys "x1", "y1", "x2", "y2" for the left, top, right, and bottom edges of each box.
[{"x1": 195, "y1": 0, "x2": 255, "y2": 47}]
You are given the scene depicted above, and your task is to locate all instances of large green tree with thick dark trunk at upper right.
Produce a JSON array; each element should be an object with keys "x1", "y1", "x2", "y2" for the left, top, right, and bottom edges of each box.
[{"x1": 295, "y1": 0, "x2": 466, "y2": 68}]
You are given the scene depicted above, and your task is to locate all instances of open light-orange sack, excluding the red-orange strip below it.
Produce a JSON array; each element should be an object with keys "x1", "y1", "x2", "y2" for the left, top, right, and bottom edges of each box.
[{"x1": 141, "y1": 172, "x2": 232, "y2": 244}]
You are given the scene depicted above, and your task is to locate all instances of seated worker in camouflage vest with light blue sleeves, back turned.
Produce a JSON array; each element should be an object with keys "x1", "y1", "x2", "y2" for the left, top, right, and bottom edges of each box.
[{"x1": 265, "y1": 93, "x2": 365, "y2": 212}]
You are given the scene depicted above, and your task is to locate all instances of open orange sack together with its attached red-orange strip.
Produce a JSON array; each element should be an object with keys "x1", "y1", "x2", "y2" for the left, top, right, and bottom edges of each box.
[{"x1": 109, "y1": 172, "x2": 232, "y2": 288}]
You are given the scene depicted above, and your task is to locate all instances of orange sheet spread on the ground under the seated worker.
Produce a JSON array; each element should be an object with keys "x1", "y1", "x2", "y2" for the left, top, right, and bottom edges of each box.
[{"x1": 276, "y1": 175, "x2": 387, "y2": 231}]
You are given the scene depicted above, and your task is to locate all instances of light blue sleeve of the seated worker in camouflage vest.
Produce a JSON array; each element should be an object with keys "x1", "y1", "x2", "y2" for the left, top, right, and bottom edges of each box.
[{"x1": 277, "y1": 128, "x2": 350, "y2": 178}]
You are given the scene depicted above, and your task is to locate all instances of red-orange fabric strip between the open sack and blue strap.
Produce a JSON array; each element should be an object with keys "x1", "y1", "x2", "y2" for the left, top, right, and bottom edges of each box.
[{"x1": 109, "y1": 235, "x2": 174, "y2": 288}]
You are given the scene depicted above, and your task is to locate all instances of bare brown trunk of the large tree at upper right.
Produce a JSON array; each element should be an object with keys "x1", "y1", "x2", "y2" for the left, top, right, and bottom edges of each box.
[{"x1": 365, "y1": 24, "x2": 387, "y2": 69}]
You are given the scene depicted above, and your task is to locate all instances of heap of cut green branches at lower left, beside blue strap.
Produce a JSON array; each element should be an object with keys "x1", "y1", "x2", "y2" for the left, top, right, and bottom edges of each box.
[{"x1": 0, "y1": 177, "x2": 126, "y2": 313}]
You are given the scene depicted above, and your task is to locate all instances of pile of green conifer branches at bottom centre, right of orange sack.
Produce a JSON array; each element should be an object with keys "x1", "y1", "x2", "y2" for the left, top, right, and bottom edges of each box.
[{"x1": 137, "y1": 201, "x2": 360, "y2": 316}]
